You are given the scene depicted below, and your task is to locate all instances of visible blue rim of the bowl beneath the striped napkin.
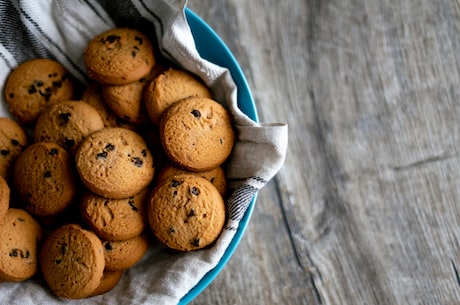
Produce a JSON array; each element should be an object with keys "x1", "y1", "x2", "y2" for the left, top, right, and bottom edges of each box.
[{"x1": 179, "y1": 8, "x2": 259, "y2": 305}]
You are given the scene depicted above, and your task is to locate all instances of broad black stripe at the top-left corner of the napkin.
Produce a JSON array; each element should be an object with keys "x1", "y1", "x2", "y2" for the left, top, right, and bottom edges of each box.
[{"x1": 0, "y1": 0, "x2": 52, "y2": 68}]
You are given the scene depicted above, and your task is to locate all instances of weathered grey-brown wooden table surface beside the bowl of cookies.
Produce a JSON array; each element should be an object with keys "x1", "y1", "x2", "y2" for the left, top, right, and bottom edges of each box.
[{"x1": 189, "y1": 0, "x2": 460, "y2": 305}]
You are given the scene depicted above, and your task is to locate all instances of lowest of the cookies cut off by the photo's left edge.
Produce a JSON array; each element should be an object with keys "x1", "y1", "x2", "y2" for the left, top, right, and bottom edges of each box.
[{"x1": 0, "y1": 208, "x2": 43, "y2": 282}]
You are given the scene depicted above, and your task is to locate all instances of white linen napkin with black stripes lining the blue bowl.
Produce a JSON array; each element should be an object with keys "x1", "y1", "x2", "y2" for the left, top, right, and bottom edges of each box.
[{"x1": 0, "y1": 0, "x2": 287, "y2": 305}]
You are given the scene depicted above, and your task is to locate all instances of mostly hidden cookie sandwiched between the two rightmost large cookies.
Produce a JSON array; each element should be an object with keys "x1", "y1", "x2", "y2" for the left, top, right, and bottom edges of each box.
[{"x1": 157, "y1": 164, "x2": 227, "y2": 196}]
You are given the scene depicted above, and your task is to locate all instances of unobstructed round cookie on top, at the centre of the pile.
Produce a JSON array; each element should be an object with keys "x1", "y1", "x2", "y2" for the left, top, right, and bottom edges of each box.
[{"x1": 75, "y1": 128, "x2": 155, "y2": 199}]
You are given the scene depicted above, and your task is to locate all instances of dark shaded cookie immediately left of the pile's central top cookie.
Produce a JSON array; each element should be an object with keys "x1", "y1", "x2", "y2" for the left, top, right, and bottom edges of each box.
[{"x1": 13, "y1": 142, "x2": 77, "y2": 216}]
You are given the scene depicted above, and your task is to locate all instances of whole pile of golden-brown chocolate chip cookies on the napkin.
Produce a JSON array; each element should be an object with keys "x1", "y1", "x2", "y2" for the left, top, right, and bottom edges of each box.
[{"x1": 0, "y1": 28, "x2": 235, "y2": 299}]
